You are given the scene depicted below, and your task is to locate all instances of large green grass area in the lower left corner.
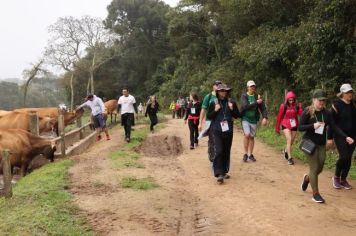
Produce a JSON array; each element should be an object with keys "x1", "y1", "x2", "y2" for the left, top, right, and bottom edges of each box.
[{"x1": 0, "y1": 160, "x2": 94, "y2": 235}]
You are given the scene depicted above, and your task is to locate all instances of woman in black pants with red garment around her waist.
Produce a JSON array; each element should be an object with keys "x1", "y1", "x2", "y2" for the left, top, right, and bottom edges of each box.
[{"x1": 184, "y1": 93, "x2": 201, "y2": 149}]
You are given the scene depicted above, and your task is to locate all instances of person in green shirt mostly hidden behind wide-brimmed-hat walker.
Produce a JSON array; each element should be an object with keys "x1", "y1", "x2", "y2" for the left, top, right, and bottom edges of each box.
[{"x1": 198, "y1": 80, "x2": 222, "y2": 162}]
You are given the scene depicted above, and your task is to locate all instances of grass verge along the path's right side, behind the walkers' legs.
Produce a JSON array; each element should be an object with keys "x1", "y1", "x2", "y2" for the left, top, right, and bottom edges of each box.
[{"x1": 257, "y1": 118, "x2": 356, "y2": 179}]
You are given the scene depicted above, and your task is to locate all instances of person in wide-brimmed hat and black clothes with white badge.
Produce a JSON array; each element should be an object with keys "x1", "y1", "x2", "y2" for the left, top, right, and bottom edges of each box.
[{"x1": 208, "y1": 84, "x2": 240, "y2": 184}]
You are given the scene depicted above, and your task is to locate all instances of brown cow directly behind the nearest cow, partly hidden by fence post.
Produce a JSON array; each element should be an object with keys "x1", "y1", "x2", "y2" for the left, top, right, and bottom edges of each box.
[{"x1": 0, "y1": 111, "x2": 56, "y2": 133}]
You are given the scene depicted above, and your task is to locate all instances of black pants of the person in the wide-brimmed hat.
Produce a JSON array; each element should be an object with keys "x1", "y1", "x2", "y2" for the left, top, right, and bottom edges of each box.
[{"x1": 212, "y1": 131, "x2": 233, "y2": 177}]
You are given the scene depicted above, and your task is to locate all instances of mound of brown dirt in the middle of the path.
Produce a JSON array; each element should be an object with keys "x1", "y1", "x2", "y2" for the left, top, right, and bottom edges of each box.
[{"x1": 137, "y1": 135, "x2": 183, "y2": 157}]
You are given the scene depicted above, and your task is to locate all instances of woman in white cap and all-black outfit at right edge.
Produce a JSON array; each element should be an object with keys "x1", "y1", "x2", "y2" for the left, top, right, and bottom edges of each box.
[{"x1": 328, "y1": 84, "x2": 356, "y2": 189}]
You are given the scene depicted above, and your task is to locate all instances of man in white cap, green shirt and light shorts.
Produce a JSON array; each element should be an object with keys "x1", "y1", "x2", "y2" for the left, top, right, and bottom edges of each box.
[{"x1": 240, "y1": 80, "x2": 267, "y2": 162}]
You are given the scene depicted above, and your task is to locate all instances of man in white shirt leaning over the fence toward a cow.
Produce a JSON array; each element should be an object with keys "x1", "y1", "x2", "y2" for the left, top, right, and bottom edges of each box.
[{"x1": 76, "y1": 94, "x2": 110, "y2": 141}]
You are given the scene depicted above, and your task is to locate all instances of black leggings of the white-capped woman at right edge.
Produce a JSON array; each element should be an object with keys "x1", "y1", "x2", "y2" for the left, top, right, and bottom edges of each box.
[{"x1": 334, "y1": 135, "x2": 356, "y2": 180}]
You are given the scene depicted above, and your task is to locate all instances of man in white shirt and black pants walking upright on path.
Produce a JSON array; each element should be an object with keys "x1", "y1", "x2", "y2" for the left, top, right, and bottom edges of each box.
[{"x1": 117, "y1": 88, "x2": 137, "y2": 142}]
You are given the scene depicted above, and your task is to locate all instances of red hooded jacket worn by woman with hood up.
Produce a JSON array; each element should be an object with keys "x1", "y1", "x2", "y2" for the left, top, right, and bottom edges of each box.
[{"x1": 275, "y1": 91, "x2": 303, "y2": 134}]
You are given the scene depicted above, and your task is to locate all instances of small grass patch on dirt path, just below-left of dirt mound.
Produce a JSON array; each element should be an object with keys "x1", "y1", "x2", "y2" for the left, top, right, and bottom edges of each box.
[{"x1": 111, "y1": 151, "x2": 145, "y2": 169}]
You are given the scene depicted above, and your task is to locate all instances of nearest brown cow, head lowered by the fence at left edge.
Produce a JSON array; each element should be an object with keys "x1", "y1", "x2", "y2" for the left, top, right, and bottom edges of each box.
[{"x1": 0, "y1": 129, "x2": 56, "y2": 176}]
